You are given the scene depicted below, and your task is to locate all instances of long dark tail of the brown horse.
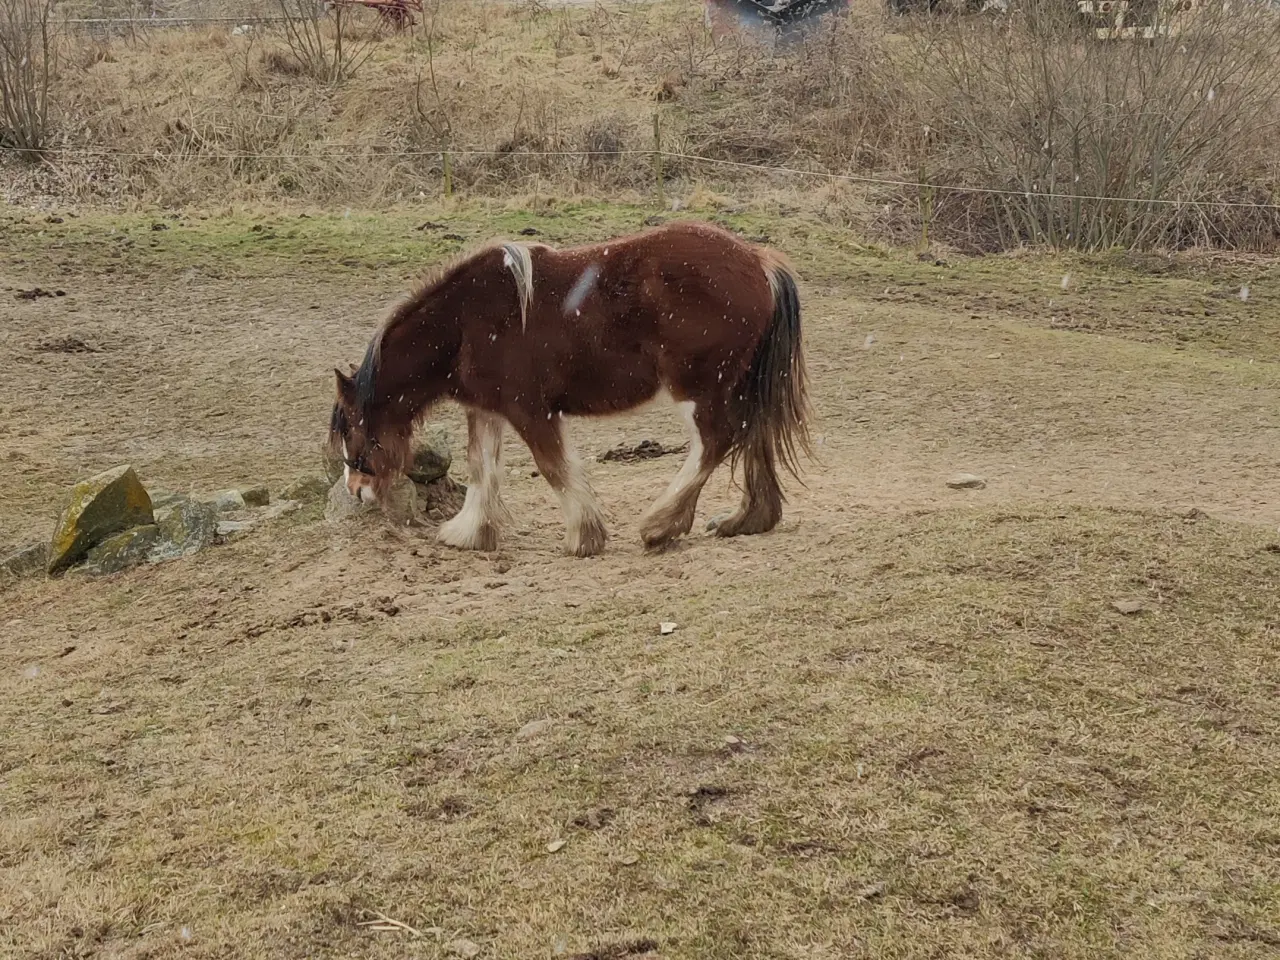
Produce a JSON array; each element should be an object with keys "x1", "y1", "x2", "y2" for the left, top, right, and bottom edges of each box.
[{"x1": 730, "y1": 255, "x2": 813, "y2": 506}]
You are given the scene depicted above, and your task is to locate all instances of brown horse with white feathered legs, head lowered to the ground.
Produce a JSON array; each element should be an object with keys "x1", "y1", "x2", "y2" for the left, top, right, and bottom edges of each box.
[{"x1": 330, "y1": 224, "x2": 809, "y2": 557}]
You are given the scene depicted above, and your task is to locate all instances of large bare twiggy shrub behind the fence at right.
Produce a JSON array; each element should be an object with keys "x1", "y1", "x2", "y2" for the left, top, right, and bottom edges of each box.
[{"x1": 911, "y1": 0, "x2": 1280, "y2": 250}]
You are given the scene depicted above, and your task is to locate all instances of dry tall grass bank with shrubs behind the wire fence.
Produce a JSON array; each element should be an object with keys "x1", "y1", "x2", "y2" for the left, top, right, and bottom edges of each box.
[{"x1": 15, "y1": 0, "x2": 1280, "y2": 250}]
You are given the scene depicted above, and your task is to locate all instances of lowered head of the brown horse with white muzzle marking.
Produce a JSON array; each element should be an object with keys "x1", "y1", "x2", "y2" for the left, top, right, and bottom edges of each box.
[{"x1": 329, "y1": 369, "x2": 408, "y2": 503}]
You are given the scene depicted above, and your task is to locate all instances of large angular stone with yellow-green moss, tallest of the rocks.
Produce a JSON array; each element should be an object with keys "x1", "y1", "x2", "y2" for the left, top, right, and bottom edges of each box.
[{"x1": 46, "y1": 466, "x2": 155, "y2": 573}]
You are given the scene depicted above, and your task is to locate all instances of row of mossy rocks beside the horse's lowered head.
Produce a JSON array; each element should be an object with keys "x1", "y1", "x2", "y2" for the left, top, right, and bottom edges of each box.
[{"x1": 0, "y1": 433, "x2": 466, "y2": 577}]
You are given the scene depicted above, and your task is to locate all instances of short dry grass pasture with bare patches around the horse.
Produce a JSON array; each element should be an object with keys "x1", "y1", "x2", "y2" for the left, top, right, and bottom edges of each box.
[{"x1": 0, "y1": 201, "x2": 1280, "y2": 960}]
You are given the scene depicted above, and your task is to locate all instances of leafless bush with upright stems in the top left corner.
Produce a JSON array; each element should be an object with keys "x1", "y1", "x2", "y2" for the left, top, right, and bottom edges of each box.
[{"x1": 0, "y1": 0, "x2": 58, "y2": 159}]
